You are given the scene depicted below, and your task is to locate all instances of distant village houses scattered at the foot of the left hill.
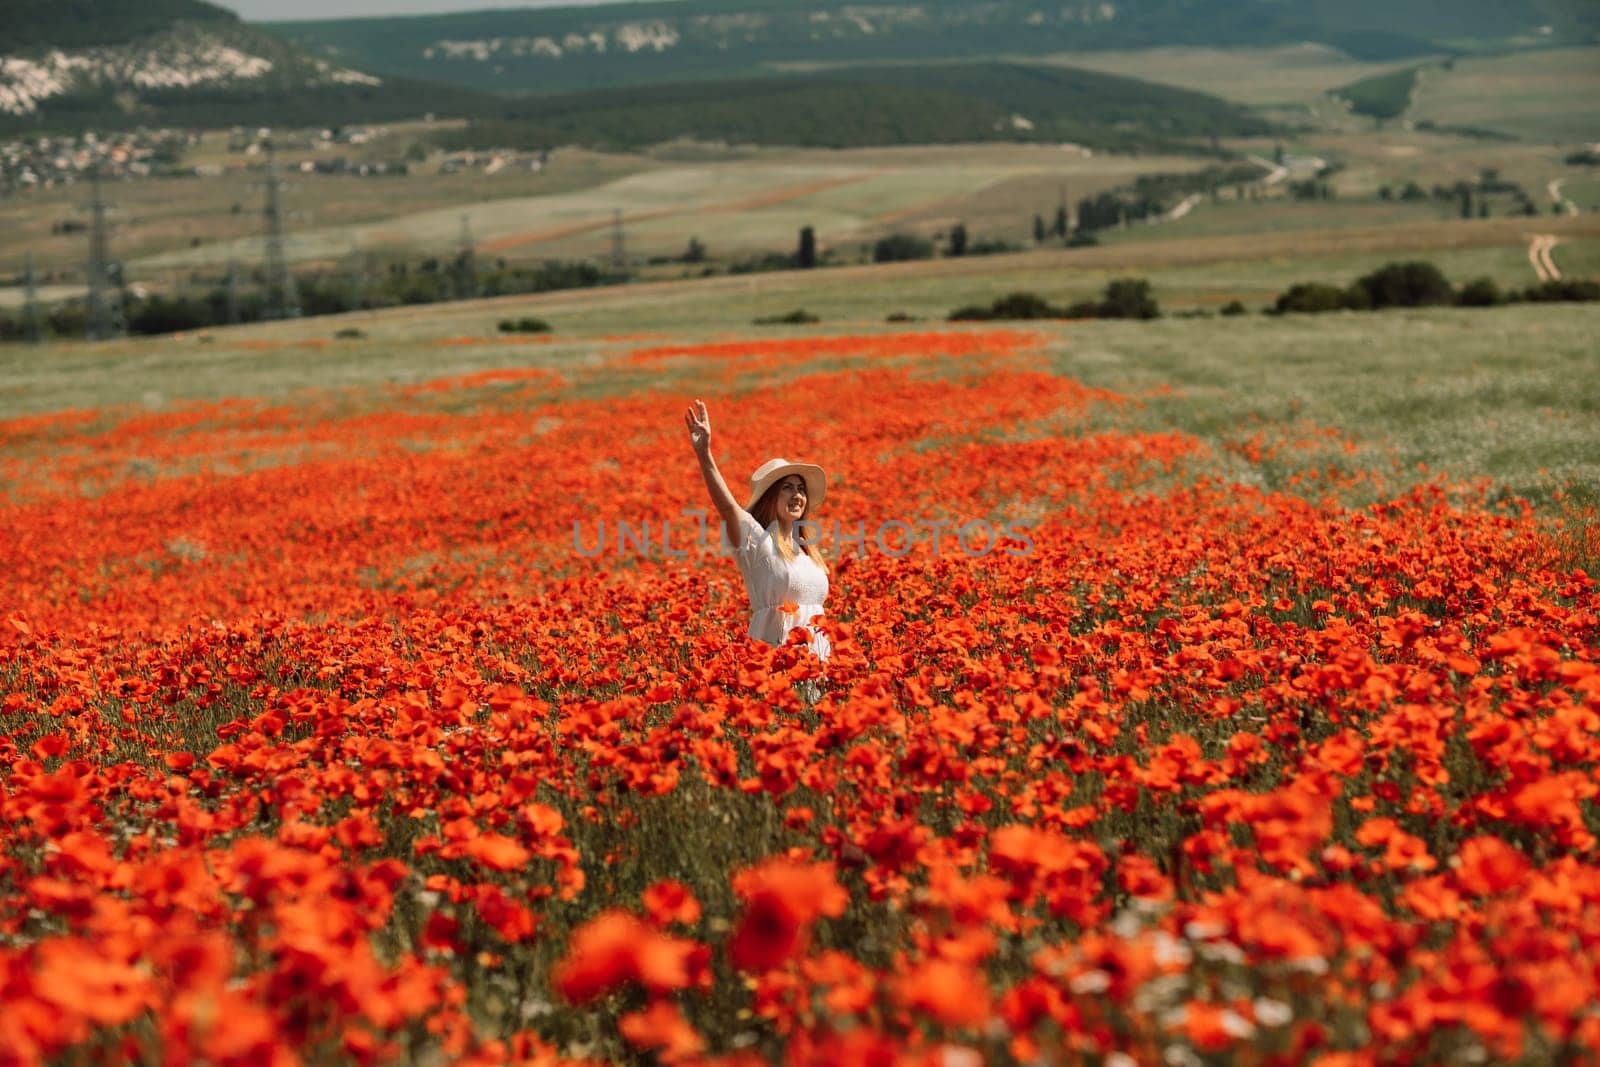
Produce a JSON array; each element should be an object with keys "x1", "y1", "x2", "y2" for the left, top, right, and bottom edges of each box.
[{"x1": 0, "y1": 126, "x2": 549, "y2": 197}]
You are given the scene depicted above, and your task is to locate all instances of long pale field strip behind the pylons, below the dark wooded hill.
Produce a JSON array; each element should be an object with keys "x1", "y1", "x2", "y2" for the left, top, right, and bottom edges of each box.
[{"x1": 0, "y1": 146, "x2": 1202, "y2": 278}]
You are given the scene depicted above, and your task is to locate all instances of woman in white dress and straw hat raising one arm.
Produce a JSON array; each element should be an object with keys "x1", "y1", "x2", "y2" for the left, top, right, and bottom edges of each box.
[{"x1": 683, "y1": 400, "x2": 830, "y2": 659}]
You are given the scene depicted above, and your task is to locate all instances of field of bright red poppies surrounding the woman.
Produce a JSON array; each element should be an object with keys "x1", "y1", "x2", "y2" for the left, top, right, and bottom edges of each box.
[{"x1": 0, "y1": 330, "x2": 1600, "y2": 1067}]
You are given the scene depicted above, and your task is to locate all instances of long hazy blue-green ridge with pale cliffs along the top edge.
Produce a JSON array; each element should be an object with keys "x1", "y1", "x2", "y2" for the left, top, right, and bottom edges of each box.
[{"x1": 267, "y1": 0, "x2": 1600, "y2": 94}]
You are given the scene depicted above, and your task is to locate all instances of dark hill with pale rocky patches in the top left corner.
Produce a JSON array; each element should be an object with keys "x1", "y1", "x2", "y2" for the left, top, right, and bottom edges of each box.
[{"x1": 0, "y1": 0, "x2": 485, "y2": 133}]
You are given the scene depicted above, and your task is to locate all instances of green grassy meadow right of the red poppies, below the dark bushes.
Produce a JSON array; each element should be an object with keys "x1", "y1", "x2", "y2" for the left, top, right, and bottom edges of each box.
[{"x1": 1051, "y1": 306, "x2": 1600, "y2": 501}]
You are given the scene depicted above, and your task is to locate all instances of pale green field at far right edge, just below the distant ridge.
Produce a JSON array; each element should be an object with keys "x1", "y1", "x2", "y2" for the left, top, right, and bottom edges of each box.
[{"x1": 1406, "y1": 48, "x2": 1600, "y2": 144}]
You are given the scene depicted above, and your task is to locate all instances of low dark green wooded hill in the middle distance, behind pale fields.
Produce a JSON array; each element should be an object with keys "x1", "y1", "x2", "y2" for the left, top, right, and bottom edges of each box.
[{"x1": 442, "y1": 62, "x2": 1270, "y2": 150}]
